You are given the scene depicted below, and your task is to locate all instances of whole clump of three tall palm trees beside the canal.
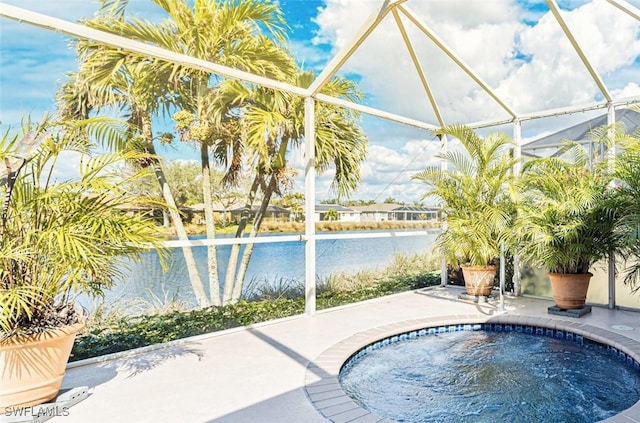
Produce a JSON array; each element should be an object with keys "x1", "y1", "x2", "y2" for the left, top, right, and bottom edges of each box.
[{"x1": 63, "y1": 0, "x2": 366, "y2": 306}]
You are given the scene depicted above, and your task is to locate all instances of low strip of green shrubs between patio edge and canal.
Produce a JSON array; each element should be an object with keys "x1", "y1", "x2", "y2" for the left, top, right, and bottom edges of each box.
[{"x1": 70, "y1": 272, "x2": 440, "y2": 361}]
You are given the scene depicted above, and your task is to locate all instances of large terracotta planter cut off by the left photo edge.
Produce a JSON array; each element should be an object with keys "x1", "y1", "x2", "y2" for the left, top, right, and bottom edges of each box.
[{"x1": 0, "y1": 323, "x2": 84, "y2": 410}]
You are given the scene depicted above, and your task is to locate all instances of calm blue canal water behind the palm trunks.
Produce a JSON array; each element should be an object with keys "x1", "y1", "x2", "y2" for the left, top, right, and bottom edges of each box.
[{"x1": 79, "y1": 231, "x2": 436, "y2": 309}]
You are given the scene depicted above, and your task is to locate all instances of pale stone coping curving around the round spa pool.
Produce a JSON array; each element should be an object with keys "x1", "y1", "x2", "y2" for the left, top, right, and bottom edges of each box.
[{"x1": 304, "y1": 314, "x2": 640, "y2": 423}]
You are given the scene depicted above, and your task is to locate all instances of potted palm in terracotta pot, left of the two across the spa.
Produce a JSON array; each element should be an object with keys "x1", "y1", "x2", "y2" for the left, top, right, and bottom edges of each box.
[{"x1": 413, "y1": 125, "x2": 516, "y2": 296}]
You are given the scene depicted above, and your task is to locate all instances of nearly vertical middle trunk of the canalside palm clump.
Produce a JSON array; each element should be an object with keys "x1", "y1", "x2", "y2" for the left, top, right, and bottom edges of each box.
[{"x1": 200, "y1": 142, "x2": 222, "y2": 306}]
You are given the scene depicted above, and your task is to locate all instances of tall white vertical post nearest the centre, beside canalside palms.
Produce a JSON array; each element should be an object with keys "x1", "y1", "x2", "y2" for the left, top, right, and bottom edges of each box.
[{"x1": 304, "y1": 97, "x2": 316, "y2": 316}]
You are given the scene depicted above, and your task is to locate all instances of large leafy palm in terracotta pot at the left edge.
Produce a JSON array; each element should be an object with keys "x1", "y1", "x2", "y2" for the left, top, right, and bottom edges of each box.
[{"x1": 0, "y1": 119, "x2": 168, "y2": 409}]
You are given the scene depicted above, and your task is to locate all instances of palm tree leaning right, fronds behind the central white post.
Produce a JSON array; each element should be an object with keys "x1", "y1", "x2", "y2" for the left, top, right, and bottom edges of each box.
[{"x1": 224, "y1": 72, "x2": 367, "y2": 302}]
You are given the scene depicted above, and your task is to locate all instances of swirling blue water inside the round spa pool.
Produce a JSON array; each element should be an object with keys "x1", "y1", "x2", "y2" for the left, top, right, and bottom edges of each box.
[{"x1": 340, "y1": 330, "x2": 640, "y2": 423}]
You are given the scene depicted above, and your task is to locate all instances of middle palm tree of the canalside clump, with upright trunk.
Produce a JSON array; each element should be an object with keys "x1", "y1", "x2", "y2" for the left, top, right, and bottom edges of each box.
[{"x1": 84, "y1": 0, "x2": 295, "y2": 304}]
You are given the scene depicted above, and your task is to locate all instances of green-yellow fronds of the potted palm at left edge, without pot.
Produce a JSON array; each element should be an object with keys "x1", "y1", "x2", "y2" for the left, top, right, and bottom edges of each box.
[{"x1": 0, "y1": 118, "x2": 165, "y2": 338}]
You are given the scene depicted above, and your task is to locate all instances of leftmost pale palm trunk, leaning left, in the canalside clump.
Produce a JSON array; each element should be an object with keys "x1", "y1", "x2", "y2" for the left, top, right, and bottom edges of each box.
[{"x1": 142, "y1": 114, "x2": 209, "y2": 308}]
